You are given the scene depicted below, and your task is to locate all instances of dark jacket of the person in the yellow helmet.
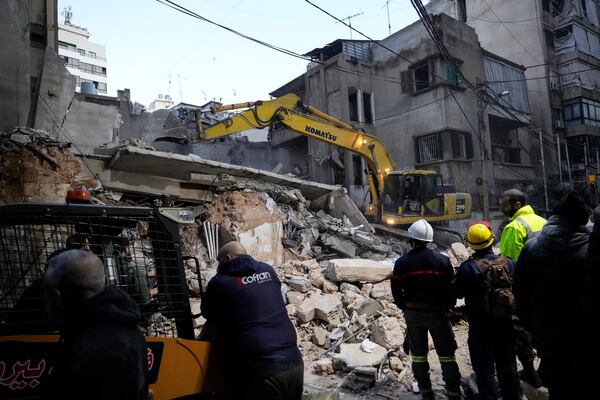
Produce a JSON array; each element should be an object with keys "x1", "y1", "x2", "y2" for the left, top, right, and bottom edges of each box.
[{"x1": 454, "y1": 252, "x2": 515, "y2": 321}]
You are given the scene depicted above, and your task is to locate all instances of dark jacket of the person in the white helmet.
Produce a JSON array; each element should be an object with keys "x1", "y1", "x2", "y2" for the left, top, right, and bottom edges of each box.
[{"x1": 391, "y1": 247, "x2": 456, "y2": 311}]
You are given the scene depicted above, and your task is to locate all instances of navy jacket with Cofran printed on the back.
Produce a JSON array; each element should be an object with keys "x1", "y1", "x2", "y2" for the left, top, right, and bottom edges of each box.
[{"x1": 201, "y1": 255, "x2": 302, "y2": 382}]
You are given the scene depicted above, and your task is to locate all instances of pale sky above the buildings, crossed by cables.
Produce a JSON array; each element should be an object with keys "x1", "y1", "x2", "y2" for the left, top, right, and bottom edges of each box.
[{"x1": 58, "y1": 0, "x2": 417, "y2": 106}]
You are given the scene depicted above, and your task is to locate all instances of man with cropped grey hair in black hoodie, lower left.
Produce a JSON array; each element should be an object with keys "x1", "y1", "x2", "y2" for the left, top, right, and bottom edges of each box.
[{"x1": 43, "y1": 250, "x2": 148, "y2": 400}]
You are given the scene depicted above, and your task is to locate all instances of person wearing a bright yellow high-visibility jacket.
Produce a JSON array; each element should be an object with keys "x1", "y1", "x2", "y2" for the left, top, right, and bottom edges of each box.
[{"x1": 500, "y1": 189, "x2": 546, "y2": 388}]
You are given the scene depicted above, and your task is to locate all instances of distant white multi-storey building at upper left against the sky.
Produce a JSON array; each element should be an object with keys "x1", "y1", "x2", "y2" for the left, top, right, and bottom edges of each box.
[{"x1": 58, "y1": 23, "x2": 108, "y2": 95}]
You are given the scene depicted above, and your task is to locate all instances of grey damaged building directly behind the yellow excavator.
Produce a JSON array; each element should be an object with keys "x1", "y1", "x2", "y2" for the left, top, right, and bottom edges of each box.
[{"x1": 271, "y1": 14, "x2": 535, "y2": 209}]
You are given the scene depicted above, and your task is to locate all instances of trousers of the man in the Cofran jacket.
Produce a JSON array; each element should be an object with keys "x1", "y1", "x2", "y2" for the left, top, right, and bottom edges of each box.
[{"x1": 227, "y1": 364, "x2": 304, "y2": 400}]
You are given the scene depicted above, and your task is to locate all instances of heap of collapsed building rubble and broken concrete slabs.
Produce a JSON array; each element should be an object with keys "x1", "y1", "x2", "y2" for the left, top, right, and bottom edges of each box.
[{"x1": 0, "y1": 128, "x2": 548, "y2": 398}]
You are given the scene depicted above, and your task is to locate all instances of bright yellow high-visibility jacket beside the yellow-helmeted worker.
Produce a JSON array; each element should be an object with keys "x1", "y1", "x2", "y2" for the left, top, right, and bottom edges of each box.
[{"x1": 500, "y1": 205, "x2": 546, "y2": 262}]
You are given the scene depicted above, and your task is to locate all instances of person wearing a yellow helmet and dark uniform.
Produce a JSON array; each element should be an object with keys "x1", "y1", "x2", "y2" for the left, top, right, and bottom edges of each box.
[{"x1": 454, "y1": 223, "x2": 520, "y2": 400}]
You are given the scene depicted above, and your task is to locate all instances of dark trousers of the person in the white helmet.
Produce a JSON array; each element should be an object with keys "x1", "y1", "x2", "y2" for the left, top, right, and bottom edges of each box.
[{"x1": 404, "y1": 309, "x2": 460, "y2": 398}]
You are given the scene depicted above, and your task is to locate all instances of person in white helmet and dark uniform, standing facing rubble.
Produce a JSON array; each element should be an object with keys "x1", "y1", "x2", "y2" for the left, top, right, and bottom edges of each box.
[{"x1": 391, "y1": 219, "x2": 460, "y2": 400}]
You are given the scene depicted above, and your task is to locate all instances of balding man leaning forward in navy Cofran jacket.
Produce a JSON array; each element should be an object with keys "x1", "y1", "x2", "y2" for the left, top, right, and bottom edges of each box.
[{"x1": 201, "y1": 242, "x2": 304, "y2": 400}]
